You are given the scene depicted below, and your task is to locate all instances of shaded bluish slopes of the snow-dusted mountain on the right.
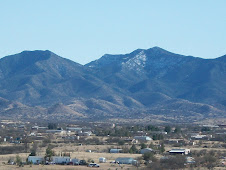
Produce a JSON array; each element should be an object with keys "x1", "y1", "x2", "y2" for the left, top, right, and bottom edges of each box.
[{"x1": 86, "y1": 47, "x2": 226, "y2": 104}]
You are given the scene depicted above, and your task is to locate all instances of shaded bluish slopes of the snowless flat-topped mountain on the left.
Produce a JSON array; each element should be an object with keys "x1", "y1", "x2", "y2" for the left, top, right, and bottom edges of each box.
[{"x1": 0, "y1": 51, "x2": 122, "y2": 106}]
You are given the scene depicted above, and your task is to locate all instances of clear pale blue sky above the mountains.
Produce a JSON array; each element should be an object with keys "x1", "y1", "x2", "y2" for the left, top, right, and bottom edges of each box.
[{"x1": 0, "y1": 0, "x2": 226, "y2": 64}]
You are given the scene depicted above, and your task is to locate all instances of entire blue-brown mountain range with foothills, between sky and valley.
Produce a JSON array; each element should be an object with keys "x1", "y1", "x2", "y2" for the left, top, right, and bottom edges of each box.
[{"x1": 0, "y1": 47, "x2": 226, "y2": 120}]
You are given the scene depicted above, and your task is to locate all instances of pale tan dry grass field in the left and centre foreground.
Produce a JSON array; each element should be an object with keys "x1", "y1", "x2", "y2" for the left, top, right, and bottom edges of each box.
[{"x1": 0, "y1": 144, "x2": 141, "y2": 170}]
